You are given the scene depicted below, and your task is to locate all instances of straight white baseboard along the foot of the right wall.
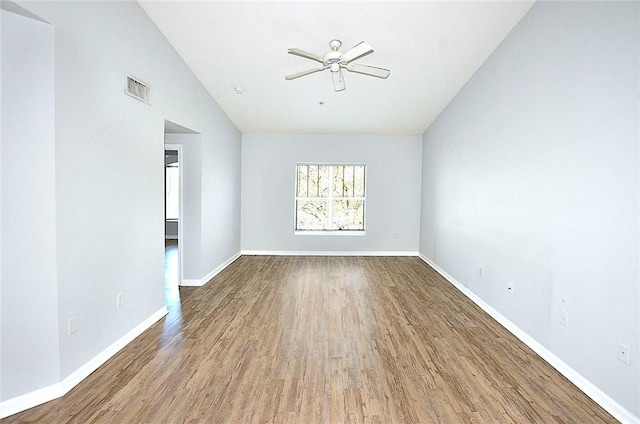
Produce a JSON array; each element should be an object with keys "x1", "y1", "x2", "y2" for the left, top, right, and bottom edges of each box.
[{"x1": 418, "y1": 253, "x2": 640, "y2": 424}]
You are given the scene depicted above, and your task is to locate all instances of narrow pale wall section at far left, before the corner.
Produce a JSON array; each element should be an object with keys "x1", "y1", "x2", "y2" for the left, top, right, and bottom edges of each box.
[{"x1": 0, "y1": 6, "x2": 60, "y2": 399}]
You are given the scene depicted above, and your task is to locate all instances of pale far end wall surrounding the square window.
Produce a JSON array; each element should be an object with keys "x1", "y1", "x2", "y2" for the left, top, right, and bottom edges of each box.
[{"x1": 242, "y1": 134, "x2": 422, "y2": 253}]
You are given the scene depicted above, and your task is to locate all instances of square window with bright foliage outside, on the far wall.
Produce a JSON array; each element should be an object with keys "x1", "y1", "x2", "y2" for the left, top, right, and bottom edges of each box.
[{"x1": 295, "y1": 164, "x2": 365, "y2": 231}]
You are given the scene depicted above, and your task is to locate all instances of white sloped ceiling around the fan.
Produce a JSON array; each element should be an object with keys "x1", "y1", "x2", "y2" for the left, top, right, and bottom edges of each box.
[{"x1": 139, "y1": 1, "x2": 534, "y2": 135}]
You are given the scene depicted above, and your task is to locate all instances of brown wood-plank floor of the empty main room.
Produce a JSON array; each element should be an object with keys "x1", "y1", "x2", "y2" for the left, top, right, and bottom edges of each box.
[{"x1": 3, "y1": 256, "x2": 616, "y2": 424}]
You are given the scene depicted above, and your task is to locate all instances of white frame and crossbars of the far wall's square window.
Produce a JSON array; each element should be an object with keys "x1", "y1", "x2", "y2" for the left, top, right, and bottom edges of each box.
[{"x1": 293, "y1": 162, "x2": 368, "y2": 236}]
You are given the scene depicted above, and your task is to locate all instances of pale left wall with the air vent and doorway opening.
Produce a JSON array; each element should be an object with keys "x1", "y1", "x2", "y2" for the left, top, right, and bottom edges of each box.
[{"x1": 2, "y1": 1, "x2": 241, "y2": 410}]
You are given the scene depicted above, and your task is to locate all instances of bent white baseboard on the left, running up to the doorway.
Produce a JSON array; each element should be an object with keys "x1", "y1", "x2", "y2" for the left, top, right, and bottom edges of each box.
[{"x1": 0, "y1": 306, "x2": 168, "y2": 419}]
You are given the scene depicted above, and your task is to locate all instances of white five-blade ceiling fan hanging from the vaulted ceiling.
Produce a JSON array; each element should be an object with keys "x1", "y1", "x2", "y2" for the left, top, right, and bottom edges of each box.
[{"x1": 285, "y1": 40, "x2": 390, "y2": 91}]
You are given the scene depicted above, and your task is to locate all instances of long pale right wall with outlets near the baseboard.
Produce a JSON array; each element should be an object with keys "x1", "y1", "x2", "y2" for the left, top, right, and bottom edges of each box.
[{"x1": 420, "y1": 2, "x2": 640, "y2": 417}]
